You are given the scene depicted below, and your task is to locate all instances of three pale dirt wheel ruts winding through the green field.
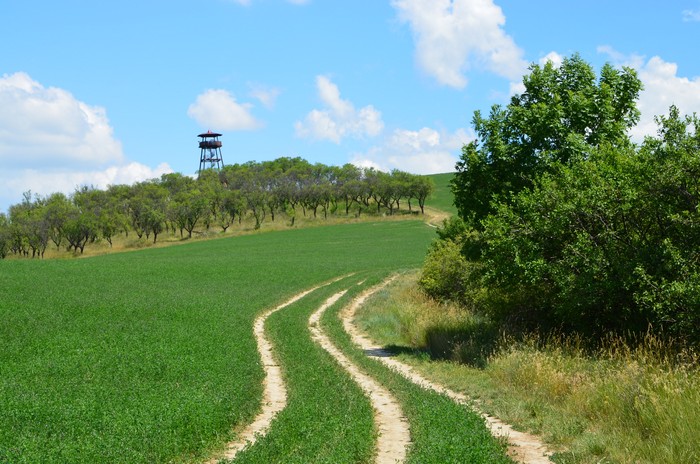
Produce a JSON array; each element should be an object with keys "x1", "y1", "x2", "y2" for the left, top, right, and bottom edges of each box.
[{"x1": 207, "y1": 278, "x2": 551, "y2": 464}]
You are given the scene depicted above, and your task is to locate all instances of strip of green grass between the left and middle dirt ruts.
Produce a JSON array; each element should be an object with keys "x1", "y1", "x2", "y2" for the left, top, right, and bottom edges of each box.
[{"x1": 230, "y1": 278, "x2": 375, "y2": 464}]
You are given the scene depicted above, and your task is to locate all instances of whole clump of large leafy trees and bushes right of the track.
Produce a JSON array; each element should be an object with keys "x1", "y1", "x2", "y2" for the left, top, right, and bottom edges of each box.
[{"x1": 422, "y1": 55, "x2": 700, "y2": 343}]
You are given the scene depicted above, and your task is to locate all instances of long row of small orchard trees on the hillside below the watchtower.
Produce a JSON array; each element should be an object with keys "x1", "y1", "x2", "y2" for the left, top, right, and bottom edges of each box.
[{"x1": 0, "y1": 158, "x2": 433, "y2": 258}]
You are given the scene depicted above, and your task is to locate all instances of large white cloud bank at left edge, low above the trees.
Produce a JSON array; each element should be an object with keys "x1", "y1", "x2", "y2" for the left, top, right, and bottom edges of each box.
[{"x1": 0, "y1": 72, "x2": 172, "y2": 212}]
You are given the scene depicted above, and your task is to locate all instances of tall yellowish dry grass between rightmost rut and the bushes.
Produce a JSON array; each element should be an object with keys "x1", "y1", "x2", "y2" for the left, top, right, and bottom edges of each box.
[{"x1": 359, "y1": 276, "x2": 700, "y2": 464}]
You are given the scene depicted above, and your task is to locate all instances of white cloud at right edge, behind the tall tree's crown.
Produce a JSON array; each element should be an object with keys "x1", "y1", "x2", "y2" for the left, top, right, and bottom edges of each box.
[{"x1": 599, "y1": 47, "x2": 700, "y2": 142}]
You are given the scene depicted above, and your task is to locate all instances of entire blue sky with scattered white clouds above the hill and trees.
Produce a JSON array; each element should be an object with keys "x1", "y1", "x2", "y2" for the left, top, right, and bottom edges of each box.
[{"x1": 0, "y1": 0, "x2": 700, "y2": 213}]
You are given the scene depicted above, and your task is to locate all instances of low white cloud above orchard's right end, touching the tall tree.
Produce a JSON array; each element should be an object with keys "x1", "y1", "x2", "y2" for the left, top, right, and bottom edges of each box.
[{"x1": 351, "y1": 127, "x2": 475, "y2": 174}]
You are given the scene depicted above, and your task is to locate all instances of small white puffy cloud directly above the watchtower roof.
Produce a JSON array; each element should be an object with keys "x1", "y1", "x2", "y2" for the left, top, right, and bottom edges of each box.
[{"x1": 187, "y1": 89, "x2": 262, "y2": 131}]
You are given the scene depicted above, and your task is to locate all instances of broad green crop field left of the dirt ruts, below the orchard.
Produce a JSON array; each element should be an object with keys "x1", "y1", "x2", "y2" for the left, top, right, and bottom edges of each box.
[{"x1": 0, "y1": 221, "x2": 434, "y2": 463}]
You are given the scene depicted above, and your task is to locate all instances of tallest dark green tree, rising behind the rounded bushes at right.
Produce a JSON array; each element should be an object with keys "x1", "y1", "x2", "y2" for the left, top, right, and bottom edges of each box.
[{"x1": 452, "y1": 55, "x2": 642, "y2": 228}]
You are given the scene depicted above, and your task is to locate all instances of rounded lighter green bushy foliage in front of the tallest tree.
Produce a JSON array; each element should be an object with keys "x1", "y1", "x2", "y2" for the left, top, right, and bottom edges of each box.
[{"x1": 484, "y1": 108, "x2": 700, "y2": 342}]
